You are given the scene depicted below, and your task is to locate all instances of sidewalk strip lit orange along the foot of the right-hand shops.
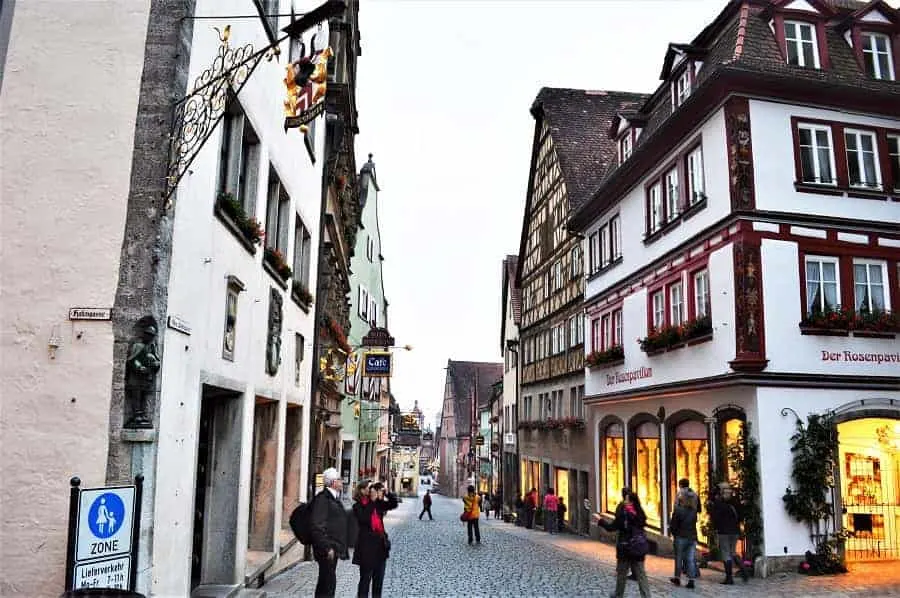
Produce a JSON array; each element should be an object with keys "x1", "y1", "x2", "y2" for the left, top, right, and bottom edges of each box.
[{"x1": 482, "y1": 519, "x2": 900, "y2": 597}]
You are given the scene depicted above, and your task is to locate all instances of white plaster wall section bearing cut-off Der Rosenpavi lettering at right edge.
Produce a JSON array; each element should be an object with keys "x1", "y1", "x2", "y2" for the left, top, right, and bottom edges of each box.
[{"x1": 761, "y1": 238, "x2": 900, "y2": 376}]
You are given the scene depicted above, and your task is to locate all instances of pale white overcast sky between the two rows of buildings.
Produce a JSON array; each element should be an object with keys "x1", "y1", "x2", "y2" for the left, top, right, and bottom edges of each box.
[{"x1": 356, "y1": 0, "x2": 740, "y2": 427}]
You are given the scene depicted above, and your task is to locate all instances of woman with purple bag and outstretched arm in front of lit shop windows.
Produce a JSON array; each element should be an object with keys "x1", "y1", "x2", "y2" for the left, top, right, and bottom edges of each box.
[{"x1": 594, "y1": 488, "x2": 650, "y2": 598}]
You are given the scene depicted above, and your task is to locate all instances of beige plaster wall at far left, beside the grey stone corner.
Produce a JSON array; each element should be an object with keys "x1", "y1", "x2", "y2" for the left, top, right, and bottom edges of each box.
[{"x1": 0, "y1": 0, "x2": 149, "y2": 597}]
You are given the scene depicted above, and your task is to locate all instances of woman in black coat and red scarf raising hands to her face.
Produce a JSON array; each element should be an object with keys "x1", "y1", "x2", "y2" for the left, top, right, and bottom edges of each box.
[{"x1": 353, "y1": 482, "x2": 397, "y2": 598}]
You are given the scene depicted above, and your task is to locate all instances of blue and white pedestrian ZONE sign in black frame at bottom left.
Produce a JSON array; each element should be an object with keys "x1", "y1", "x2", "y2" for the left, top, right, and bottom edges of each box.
[{"x1": 66, "y1": 476, "x2": 143, "y2": 591}]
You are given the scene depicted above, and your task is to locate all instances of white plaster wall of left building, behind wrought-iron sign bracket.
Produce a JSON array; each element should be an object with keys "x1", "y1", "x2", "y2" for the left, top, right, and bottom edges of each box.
[{"x1": 153, "y1": 0, "x2": 327, "y2": 596}]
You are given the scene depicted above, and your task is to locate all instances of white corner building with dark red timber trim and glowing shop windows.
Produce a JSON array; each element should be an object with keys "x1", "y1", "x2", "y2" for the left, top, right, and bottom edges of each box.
[{"x1": 570, "y1": 2, "x2": 900, "y2": 572}]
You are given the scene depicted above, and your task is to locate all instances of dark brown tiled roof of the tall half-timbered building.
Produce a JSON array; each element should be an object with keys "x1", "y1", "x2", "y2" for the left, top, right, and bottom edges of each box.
[{"x1": 531, "y1": 87, "x2": 647, "y2": 211}]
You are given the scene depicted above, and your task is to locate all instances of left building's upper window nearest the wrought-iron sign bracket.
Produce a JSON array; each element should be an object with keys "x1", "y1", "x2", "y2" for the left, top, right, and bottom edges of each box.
[{"x1": 216, "y1": 97, "x2": 259, "y2": 215}]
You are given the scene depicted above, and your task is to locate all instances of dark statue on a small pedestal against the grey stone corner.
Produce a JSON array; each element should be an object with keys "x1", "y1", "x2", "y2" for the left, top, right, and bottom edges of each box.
[{"x1": 125, "y1": 316, "x2": 159, "y2": 428}]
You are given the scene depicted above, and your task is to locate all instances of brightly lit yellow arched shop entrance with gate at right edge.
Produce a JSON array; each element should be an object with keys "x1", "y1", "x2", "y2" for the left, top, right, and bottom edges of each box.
[{"x1": 838, "y1": 418, "x2": 900, "y2": 561}]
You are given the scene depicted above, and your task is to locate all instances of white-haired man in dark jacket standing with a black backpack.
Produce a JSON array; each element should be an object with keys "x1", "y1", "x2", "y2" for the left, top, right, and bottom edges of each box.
[{"x1": 309, "y1": 467, "x2": 350, "y2": 598}]
